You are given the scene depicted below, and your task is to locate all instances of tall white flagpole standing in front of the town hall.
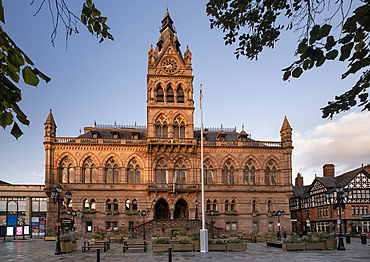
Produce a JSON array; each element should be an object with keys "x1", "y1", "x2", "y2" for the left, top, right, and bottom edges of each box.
[{"x1": 200, "y1": 84, "x2": 208, "y2": 253}]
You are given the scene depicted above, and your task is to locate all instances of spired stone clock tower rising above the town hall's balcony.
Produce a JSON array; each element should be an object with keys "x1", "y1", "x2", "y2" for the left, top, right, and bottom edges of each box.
[{"x1": 147, "y1": 10, "x2": 194, "y2": 138}]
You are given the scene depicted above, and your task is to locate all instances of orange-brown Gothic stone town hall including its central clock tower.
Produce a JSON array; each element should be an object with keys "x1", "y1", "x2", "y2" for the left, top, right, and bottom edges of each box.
[{"x1": 44, "y1": 12, "x2": 293, "y2": 238}]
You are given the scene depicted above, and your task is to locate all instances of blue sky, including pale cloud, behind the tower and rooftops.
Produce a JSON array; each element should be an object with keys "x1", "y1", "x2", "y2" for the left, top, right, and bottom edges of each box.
[{"x1": 0, "y1": 0, "x2": 370, "y2": 185}]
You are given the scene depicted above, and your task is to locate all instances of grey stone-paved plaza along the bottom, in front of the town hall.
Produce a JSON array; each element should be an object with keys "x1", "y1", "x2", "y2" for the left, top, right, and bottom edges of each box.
[{"x1": 0, "y1": 239, "x2": 370, "y2": 262}]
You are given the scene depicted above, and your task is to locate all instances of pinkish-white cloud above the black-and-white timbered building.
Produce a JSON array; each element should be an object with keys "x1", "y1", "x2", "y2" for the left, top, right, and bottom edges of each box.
[{"x1": 293, "y1": 112, "x2": 370, "y2": 185}]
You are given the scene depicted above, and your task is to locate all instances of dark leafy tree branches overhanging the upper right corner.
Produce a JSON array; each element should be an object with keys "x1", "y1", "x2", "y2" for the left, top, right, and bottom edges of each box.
[{"x1": 206, "y1": 0, "x2": 370, "y2": 118}]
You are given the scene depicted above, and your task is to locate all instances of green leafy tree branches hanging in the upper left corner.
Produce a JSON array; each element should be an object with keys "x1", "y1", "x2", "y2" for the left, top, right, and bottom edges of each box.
[{"x1": 0, "y1": 0, "x2": 114, "y2": 139}]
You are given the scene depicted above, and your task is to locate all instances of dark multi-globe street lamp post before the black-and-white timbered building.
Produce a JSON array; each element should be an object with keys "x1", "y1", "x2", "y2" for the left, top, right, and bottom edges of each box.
[{"x1": 326, "y1": 185, "x2": 352, "y2": 251}]
